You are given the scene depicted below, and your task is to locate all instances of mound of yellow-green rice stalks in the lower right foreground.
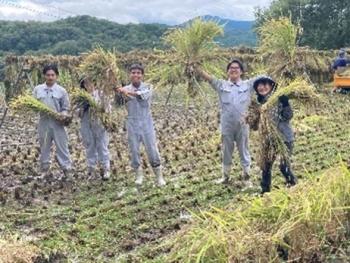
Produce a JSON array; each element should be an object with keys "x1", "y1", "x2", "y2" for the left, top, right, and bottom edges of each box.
[{"x1": 168, "y1": 167, "x2": 350, "y2": 263}]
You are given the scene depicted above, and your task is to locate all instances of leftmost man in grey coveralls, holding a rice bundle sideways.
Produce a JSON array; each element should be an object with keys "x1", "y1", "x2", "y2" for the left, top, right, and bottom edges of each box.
[{"x1": 33, "y1": 65, "x2": 72, "y2": 177}]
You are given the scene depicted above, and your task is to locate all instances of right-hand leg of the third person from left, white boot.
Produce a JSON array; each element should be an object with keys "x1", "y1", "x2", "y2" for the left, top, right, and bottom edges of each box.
[{"x1": 142, "y1": 131, "x2": 166, "y2": 187}]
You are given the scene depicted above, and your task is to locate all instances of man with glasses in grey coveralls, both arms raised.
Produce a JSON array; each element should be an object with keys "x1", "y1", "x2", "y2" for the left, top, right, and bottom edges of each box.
[{"x1": 195, "y1": 59, "x2": 255, "y2": 187}]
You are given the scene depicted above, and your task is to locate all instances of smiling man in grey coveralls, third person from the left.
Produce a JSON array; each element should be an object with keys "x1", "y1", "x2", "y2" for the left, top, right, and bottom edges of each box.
[{"x1": 118, "y1": 64, "x2": 166, "y2": 187}]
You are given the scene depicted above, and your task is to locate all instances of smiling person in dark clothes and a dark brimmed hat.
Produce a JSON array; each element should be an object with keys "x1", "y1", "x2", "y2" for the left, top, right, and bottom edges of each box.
[{"x1": 253, "y1": 76, "x2": 297, "y2": 193}]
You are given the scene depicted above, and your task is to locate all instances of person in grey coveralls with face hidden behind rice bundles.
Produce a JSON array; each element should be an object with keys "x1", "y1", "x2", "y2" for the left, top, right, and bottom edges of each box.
[{"x1": 79, "y1": 78, "x2": 111, "y2": 180}]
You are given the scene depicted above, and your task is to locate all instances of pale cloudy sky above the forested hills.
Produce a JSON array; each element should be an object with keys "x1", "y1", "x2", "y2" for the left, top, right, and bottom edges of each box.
[{"x1": 0, "y1": 0, "x2": 271, "y2": 25}]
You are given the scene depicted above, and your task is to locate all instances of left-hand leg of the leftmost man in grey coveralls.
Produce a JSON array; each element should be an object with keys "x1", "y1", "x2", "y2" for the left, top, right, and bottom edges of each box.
[{"x1": 38, "y1": 122, "x2": 53, "y2": 174}]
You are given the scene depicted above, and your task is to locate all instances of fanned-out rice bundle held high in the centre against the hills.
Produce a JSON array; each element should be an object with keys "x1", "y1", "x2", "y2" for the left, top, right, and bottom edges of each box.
[{"x1": 149, "y1": 19, "x2": 223, "y2": 97}]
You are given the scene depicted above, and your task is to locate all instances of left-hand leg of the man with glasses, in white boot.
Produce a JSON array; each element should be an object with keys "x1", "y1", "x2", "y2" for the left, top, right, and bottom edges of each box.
[{"x1": 217, "y1": 134, "x2": 235, "y2": 183}]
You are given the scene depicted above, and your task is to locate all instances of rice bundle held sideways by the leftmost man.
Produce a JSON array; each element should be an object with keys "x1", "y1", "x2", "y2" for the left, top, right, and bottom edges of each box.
[{"x1": 10, "y1": 94, "x2": 73, "y2": 126}]
